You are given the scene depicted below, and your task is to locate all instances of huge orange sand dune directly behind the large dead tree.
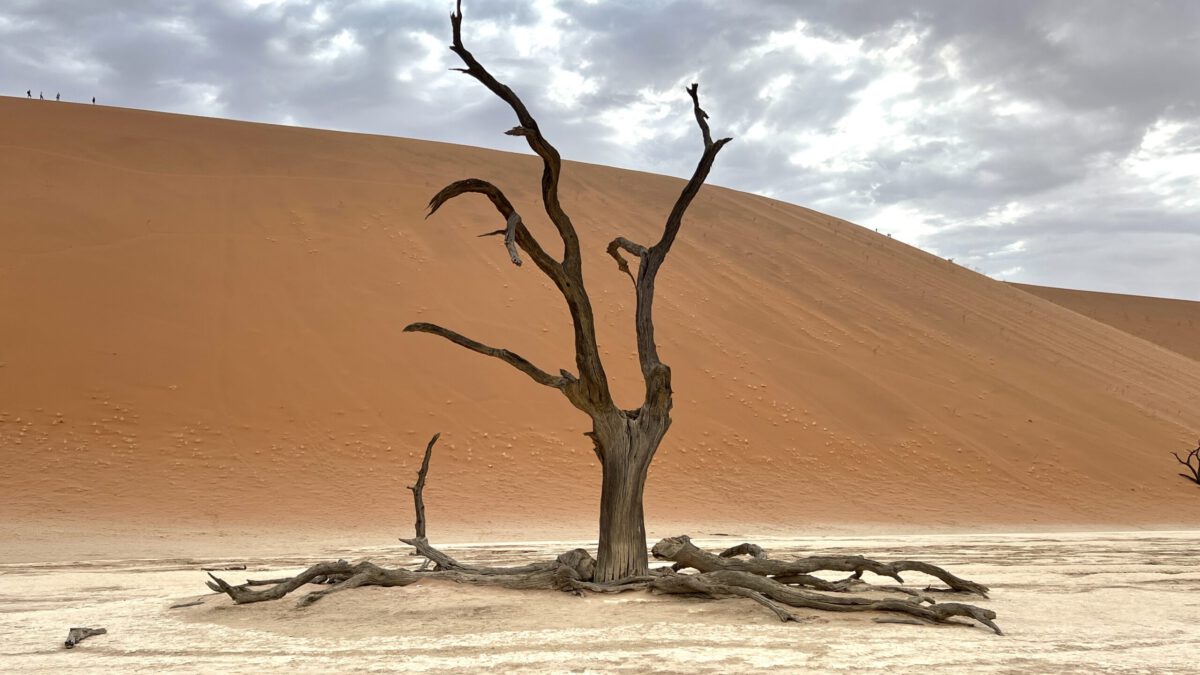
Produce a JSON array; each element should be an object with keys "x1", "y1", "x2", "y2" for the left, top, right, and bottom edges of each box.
[{"x1": 0, "y1": 98, "x2": 1200, "y2": 536}]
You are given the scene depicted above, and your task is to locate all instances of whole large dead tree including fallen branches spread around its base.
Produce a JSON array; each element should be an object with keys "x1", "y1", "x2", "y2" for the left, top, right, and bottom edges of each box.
[{"x1": 201, "y1": 1, "x2": 1000, "y2": 634}]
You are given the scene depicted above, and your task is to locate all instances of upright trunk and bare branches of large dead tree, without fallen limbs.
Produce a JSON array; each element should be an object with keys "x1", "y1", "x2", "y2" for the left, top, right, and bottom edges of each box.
[{"x1": 404, "y1": 0, "x2": 731, "y2": 581}]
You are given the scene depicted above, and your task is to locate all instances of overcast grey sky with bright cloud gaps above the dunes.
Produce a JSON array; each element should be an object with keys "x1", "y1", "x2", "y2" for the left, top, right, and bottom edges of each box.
[{"x1": 0, "y1": 0, "x2": 1200, "y2": 300}]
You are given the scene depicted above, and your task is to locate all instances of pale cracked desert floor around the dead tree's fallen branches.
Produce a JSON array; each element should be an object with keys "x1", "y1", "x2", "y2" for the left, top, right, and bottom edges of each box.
[{"x1": 0, "y1": 531, "x2": 1200, "y2": 673}]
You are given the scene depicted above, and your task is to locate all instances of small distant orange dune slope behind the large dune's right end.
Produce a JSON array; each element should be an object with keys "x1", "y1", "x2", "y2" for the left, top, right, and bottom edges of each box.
[{"x1": 1013, "y1": 283, "x2": 1200, "y2": 360}]
